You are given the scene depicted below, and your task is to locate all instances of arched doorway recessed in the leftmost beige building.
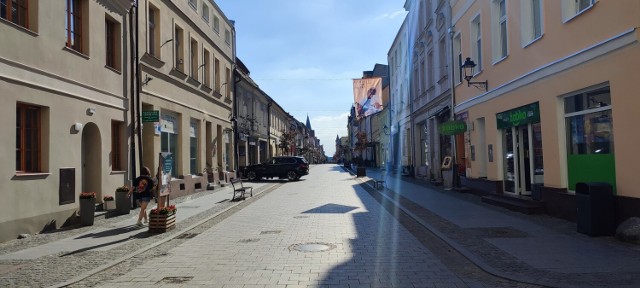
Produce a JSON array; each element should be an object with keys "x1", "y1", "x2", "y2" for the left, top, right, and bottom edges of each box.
[{"x1": 81, "y1": 123, "x2": 102, "y2": 201}]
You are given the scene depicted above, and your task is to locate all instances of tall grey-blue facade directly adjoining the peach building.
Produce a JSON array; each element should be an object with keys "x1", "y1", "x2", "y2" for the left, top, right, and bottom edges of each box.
[{"x1": 405, "y1": 0, "x2": 456, "y2": 182}]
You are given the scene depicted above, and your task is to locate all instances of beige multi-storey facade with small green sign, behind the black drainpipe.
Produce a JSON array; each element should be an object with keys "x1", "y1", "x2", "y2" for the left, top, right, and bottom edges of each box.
[{"x1": 137, "y1": 0, "x2": 237, "y2": 196}]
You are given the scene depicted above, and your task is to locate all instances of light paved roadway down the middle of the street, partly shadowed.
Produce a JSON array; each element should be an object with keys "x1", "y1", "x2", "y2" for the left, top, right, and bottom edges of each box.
[{"x1": 104, "y1": 166, "x2": 464, "y2": 287}]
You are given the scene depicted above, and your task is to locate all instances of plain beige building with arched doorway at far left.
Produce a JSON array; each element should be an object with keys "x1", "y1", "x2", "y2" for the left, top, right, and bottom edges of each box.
[{"x1": 0, "y1": 0, "x2": 130, "y2": 241}]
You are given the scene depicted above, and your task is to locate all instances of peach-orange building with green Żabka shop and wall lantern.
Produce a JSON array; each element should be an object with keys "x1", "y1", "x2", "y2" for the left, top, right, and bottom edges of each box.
[{"x1": 449, "y1": 0, "x2": 640, "y2": 222}]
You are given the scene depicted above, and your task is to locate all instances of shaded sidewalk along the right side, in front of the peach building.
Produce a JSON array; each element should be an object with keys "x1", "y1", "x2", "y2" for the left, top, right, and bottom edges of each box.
[{"x1": 350, "y1": 168, "x2": 640, "y2": 287}]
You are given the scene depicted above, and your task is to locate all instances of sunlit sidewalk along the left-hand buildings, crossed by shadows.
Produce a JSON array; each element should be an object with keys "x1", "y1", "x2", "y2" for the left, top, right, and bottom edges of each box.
[{"x1": 0, "y1": 183, "x2": 268, "y2": 260}]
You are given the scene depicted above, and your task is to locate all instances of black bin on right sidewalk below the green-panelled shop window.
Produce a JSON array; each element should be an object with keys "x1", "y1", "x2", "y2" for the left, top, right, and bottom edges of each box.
[{"x1": 576, "y1": 182, "x2": 615, "y2": 236}]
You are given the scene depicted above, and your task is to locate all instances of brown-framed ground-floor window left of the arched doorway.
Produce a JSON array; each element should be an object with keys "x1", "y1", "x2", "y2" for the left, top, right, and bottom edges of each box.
[{"x1": 16, "y1": 103, "x2": 42, "y2": 172}]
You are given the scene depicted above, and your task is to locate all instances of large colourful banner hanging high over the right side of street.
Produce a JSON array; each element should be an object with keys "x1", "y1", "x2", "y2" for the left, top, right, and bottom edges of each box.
[{"x1": 353, "y1": 77, "x2": 383, "y2": 119}]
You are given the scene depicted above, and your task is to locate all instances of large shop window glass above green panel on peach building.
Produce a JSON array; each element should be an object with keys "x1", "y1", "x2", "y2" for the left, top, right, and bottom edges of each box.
[{"x1": 564, "y1": 87, "x2": 613, "y2": 155}]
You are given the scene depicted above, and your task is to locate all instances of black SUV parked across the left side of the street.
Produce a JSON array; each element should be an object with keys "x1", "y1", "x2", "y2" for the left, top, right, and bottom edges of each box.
[{"x1": 244, "y1": 156, "x2": 309, "y2": 181}]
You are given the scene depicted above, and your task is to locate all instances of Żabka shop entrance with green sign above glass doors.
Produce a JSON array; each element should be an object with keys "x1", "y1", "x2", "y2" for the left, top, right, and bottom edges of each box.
[{"x1": 496, "y1": 102, "x2": 544, "y2": 198}]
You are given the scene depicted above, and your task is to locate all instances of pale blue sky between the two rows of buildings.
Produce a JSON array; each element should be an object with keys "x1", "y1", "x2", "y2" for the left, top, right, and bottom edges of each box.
[{"x1": 214, "y1": 0, "x2": 406, "y2": 156}]
